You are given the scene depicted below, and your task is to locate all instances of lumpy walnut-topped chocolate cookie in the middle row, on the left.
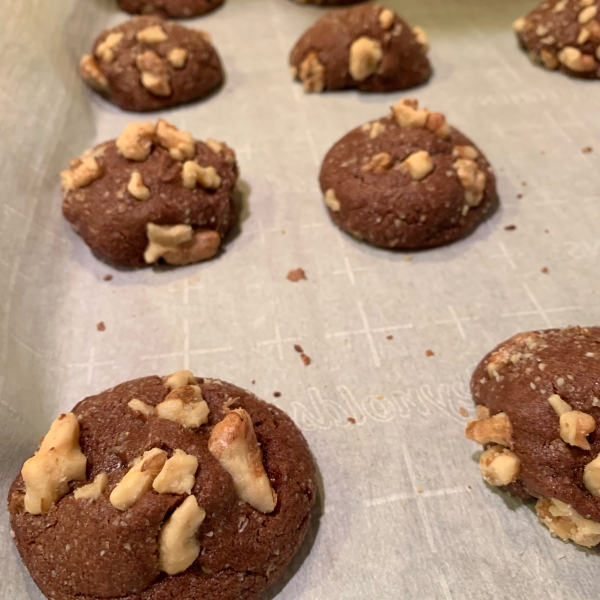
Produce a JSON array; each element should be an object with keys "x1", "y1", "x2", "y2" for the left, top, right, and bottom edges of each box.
[{"x1": 61, "y1": 119, "x2": 238, "y2": 267}]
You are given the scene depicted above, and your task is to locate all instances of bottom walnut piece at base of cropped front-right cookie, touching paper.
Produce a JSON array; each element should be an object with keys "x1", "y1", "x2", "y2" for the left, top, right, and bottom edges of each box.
[{"x1": 535, "y1": 498, "x2": 600, "y2": 548}]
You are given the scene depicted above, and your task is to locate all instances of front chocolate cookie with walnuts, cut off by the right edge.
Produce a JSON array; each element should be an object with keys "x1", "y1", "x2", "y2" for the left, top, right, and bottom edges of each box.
[{"x1": 466, "y1": 327, "x2": 600, "y2": 547}]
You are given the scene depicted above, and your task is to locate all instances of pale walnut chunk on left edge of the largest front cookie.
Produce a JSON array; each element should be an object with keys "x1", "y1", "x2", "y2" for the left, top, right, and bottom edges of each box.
[{"x1": 21, "y1": 413, "x2": 87, "y2": 515}]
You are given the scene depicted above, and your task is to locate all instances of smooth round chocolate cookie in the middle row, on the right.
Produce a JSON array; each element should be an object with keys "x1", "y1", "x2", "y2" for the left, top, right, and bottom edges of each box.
[{"x1": 320, "y1": 100, "x2": 497, "y2": 249}]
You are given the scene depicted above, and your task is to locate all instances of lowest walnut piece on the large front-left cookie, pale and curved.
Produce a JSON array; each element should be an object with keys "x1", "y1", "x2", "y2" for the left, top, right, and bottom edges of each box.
[{"x1": 158, "y1": 496, "x2": 206, "y2": 575}]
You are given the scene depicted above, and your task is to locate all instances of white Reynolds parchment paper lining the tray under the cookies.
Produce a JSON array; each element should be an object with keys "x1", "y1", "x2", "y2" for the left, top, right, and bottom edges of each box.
[{"x1": 0, "y1": 0, "x2": 600, "y2": 600}]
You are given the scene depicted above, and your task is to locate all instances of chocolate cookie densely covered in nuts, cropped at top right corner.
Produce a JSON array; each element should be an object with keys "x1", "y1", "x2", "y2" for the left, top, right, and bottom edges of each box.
[{"x1": 513, "y1": 0, "x2": 600, "y2": 79}]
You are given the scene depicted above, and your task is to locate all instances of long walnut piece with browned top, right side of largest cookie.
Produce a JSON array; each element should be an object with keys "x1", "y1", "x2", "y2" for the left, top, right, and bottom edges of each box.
[{"x1": 208, "y1": 408, "x2": 277, "y2": 513}]
